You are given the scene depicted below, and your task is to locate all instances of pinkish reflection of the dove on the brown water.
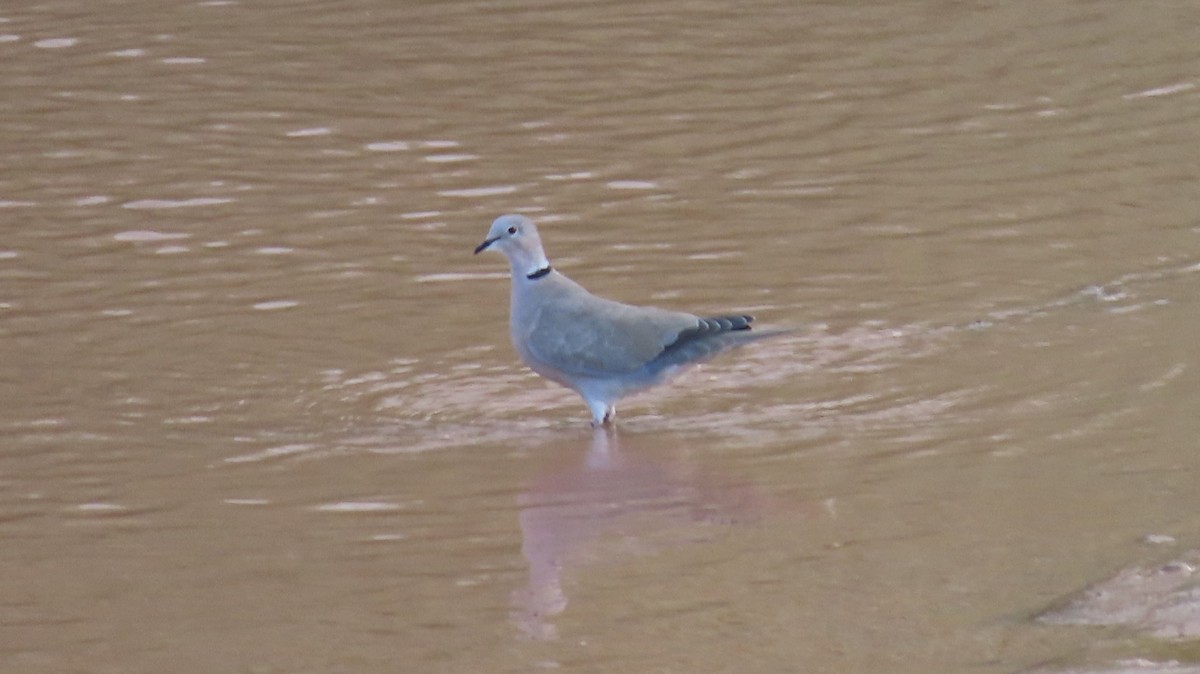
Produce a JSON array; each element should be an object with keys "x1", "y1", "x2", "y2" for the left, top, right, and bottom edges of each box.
[{"x1": 512, "y1": 427, "x2": 762, "y2": 639}]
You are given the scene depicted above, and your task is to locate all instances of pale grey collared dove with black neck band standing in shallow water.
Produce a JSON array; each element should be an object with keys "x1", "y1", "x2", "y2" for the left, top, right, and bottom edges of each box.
[{"x1": 475, "y1": 213, "x2": 787, "y2": 427}]
